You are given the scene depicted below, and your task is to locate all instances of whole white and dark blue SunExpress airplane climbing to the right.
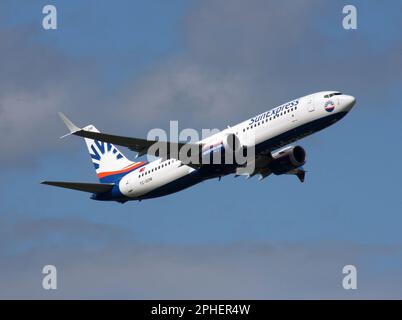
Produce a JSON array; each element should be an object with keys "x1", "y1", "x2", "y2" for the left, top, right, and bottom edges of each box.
[{"x1": 41, "y1": 91, "x2": 356, "y2": 203}]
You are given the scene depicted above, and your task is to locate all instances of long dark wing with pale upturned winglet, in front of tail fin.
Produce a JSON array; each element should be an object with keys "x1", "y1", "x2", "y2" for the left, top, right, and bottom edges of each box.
[{"x1": 59, "y1": 112, "x2": 201, "y2": 158}]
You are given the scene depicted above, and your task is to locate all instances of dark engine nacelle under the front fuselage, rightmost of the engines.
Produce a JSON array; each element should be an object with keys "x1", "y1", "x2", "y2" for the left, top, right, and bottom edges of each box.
[{"x1": 269, "y1": 146, "x2": 306, "y2": 175}]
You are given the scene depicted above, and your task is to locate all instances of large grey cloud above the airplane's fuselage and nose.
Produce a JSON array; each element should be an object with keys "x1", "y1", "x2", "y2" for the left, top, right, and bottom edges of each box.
[{"x1": 120, "y1": 0, "x2": 402, "y2": 127}]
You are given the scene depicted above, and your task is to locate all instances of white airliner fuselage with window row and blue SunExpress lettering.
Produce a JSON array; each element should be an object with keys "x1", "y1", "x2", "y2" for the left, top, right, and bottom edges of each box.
[{"x1": 119, "y1": 91, "x2": 355, "y2": 199}]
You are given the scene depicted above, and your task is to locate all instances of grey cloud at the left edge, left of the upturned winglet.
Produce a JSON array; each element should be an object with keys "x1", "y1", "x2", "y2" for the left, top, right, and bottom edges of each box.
[{"x1": 0, "y1": 27, "x2": 107, "y2": 167}]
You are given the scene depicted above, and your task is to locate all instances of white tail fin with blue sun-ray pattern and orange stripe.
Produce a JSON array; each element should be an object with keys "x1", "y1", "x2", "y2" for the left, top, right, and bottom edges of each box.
[{"x1": 83, "y1": 125, "x2": 143, "y2": 182}]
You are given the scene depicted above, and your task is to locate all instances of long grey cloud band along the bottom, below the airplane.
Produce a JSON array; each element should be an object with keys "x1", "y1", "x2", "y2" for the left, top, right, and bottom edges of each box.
[{"x1": 0, "y1": 214, "x2": 402, "y2": 299}]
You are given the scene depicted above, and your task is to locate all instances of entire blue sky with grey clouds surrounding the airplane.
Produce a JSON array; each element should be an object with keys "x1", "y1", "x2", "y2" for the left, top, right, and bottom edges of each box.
[{"x1": 0, "y1": 0, "x2": 402, "y2": 298}]
